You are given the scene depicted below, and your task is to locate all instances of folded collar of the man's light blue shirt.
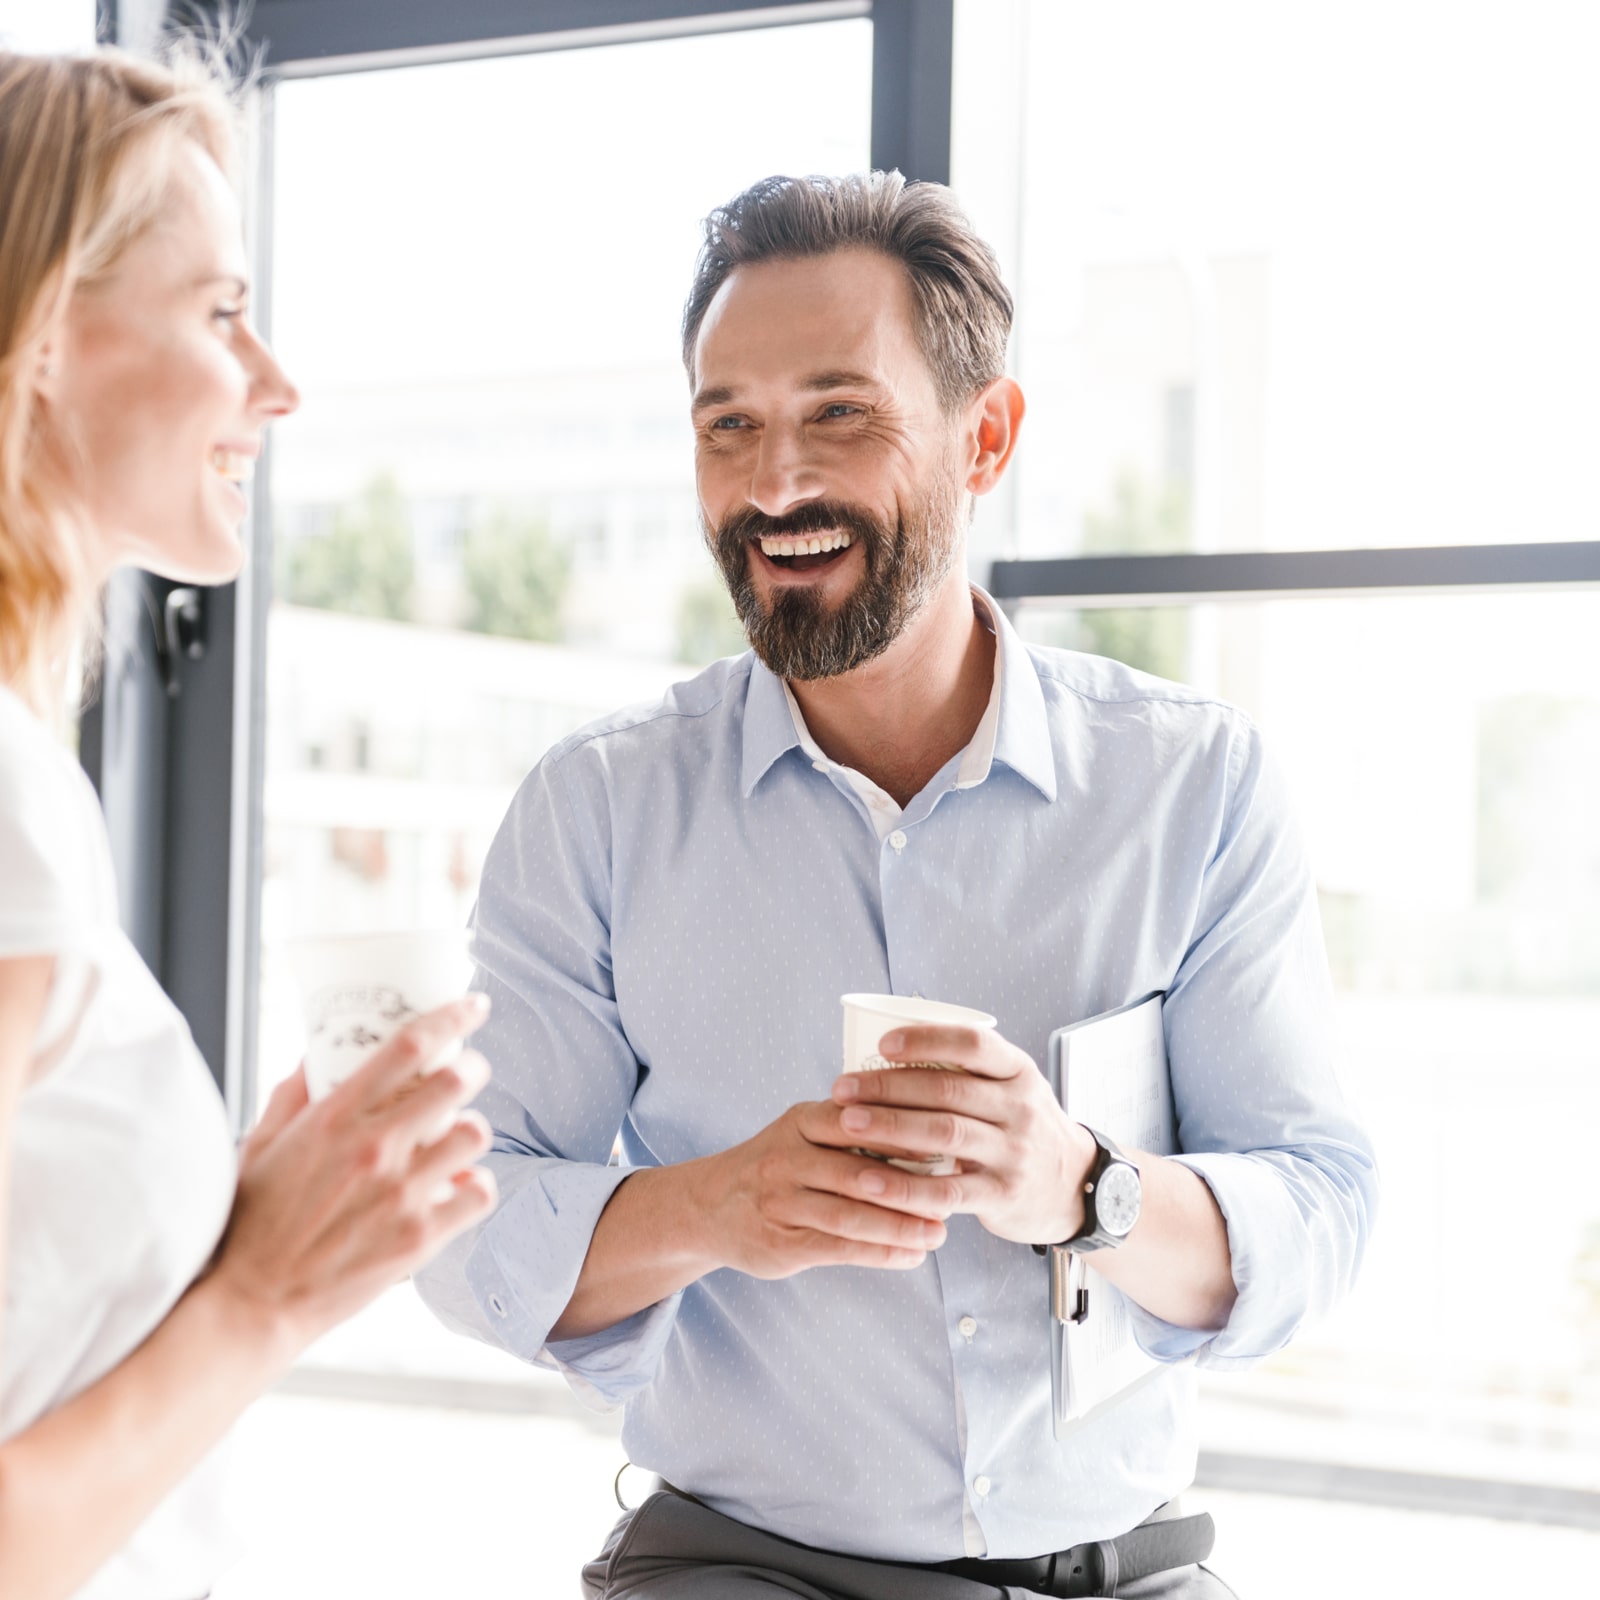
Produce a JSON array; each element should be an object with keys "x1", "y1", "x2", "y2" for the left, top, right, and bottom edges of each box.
[{"x1": 741, "y1": 584, "x2": 1056, "y2": 800}]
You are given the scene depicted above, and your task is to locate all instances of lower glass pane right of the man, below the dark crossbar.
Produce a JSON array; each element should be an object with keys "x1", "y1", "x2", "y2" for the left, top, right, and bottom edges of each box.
[{"x1": 1019, "y1": 594, "x2": 1600, "y2": 1490}]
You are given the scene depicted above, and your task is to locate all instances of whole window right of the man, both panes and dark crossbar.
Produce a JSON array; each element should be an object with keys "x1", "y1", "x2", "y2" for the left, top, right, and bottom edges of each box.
[{"x1": 952, "y1": 0, "x2": 1600, "y2": 1518}]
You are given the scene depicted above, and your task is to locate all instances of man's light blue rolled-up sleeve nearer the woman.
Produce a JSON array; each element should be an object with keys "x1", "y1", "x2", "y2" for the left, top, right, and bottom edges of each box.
[{"x1": 414, "y1": 744, "x2": 678, "y2": 1408}]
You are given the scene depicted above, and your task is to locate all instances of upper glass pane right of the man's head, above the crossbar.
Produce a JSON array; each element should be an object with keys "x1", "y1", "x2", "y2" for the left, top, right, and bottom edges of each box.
[{"x1": 954, "y1": 0, "x2": 1600, "y2": 555}]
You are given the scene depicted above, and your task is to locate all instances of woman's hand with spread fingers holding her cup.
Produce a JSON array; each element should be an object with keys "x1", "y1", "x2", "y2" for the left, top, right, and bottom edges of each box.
[{"x1": 211, "y1": 995, "x2": 496, "y2": 1355}]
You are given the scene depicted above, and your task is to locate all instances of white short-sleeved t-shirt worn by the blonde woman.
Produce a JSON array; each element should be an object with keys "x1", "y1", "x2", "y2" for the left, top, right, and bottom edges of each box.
[{"x1": 0, "y1": 686, "x2": 237, "y2": 1600}]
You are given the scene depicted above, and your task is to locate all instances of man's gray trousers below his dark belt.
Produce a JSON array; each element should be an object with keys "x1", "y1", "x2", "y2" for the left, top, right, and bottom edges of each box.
[{"x1": 584, "y1": 1493, "x2": 1237, "y2": 1600}]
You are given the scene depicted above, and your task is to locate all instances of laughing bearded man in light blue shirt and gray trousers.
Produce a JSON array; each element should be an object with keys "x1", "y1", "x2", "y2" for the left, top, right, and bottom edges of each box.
[{"x1": 419, "y1": 174, "x2": 1374, "y2": 1600}]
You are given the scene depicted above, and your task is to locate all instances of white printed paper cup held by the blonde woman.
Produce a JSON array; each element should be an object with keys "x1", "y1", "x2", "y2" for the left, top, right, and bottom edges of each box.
[{"x1": 286, "y1": 928, "x2": 472, "y2": 1099}]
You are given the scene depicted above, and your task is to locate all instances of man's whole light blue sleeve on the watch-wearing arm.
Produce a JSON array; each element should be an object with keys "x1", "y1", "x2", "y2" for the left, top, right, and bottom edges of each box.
[{"x1": 1131, "y1": 717, "x2": 1378, "y2": 1368}]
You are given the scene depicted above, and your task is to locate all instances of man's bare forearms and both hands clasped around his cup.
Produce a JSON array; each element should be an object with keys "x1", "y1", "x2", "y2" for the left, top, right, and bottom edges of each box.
[{"x1": 552, "y1": 1027, "x2": 1234, "y2": 1339}]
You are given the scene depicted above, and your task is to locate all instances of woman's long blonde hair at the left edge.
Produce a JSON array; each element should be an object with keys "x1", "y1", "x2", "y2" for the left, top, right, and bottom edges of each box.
[{"x1": 0, "y1": 48, "x2": 235, "y2": 712}]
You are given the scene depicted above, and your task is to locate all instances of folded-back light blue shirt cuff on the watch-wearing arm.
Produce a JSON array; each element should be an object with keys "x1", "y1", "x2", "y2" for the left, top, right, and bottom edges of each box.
[{"x1": 1128, "y1": 1152, "x2": 1310, "y2": 1371}]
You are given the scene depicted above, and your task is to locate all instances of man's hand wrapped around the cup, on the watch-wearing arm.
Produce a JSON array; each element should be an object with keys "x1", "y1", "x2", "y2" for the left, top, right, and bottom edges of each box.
[{"x1": 818, "y1": 1026, "x2": 1094, "y2": 1245}]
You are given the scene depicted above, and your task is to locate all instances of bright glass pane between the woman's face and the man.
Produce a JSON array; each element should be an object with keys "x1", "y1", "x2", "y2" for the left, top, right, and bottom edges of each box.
[{"x1": 259, "y1": 19, "x2": 872, "y2": 1382}]
